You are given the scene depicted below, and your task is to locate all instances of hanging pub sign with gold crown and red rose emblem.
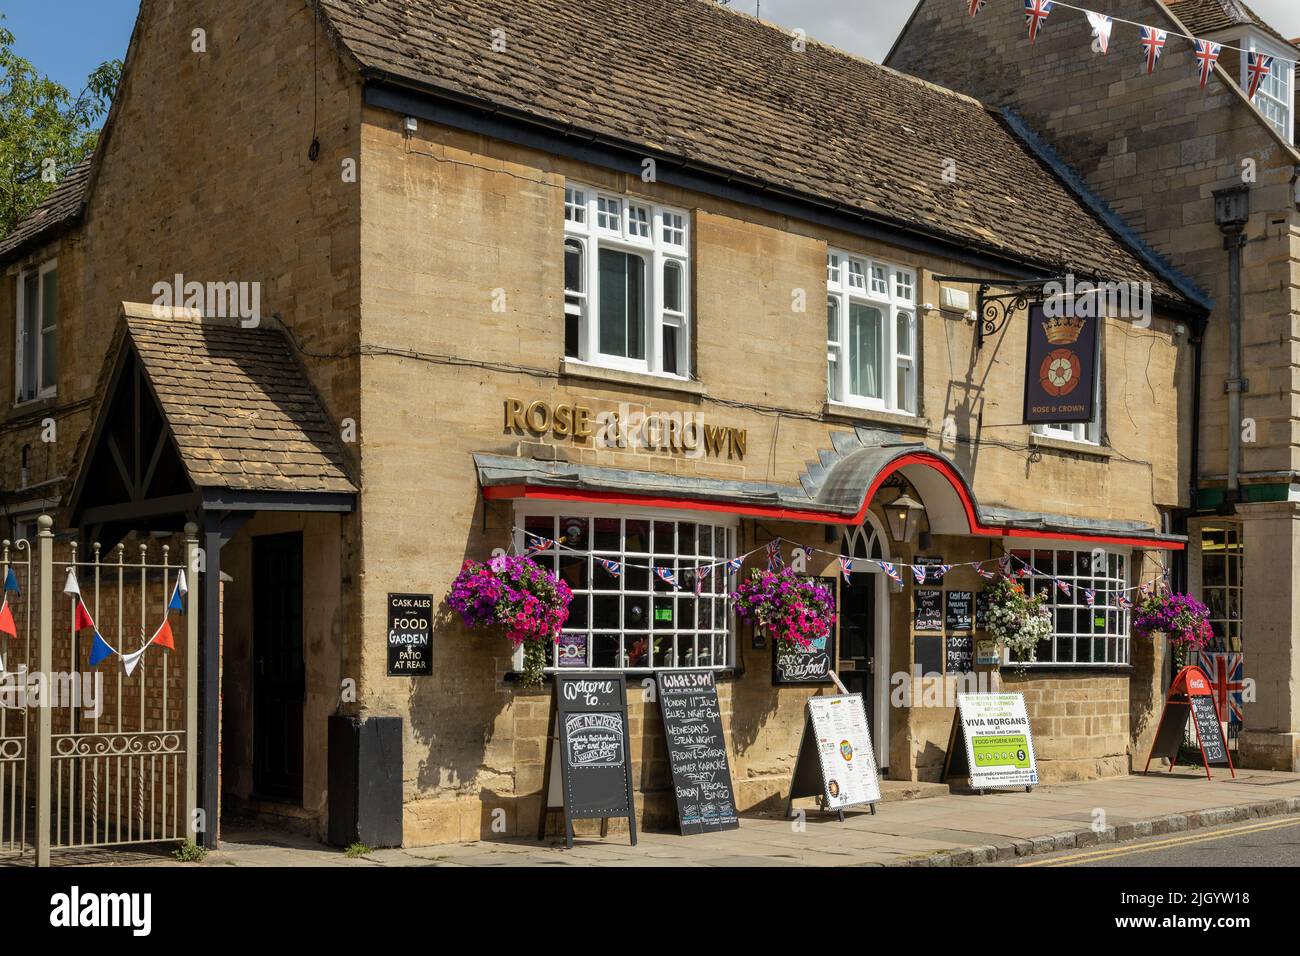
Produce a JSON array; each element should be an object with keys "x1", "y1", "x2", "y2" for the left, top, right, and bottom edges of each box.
[{"x1": 1024, "y1": 300, "x2": 1099, "y2": 425}]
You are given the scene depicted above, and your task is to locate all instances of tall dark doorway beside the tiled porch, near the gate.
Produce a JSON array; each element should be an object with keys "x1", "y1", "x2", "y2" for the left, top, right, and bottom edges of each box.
[{"x1": 252, "y1": 532, "x2": 307, "y2": 804}]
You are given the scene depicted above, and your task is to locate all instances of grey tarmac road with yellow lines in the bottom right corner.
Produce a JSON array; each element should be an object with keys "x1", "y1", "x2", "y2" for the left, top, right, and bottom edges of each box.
[{"x1": 1002, "y1": 814, "x2": 1300, "y2": 866}]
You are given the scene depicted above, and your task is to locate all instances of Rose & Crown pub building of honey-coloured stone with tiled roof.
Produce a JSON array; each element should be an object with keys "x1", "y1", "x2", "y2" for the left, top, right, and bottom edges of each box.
[{"x1": 0, "y1": 0, "x2": 1206, "y2": 844}]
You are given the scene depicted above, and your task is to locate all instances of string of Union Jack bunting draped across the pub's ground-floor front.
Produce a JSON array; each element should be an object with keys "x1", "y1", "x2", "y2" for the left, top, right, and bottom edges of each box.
[{"x1": 512, "y1": 528, "x2": 1169, "y2": 610}]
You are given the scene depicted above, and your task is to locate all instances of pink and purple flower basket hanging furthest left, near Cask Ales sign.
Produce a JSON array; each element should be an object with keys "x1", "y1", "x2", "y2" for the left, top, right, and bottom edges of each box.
[{"x1": 447, "y1": 554, "x2": 573, "y2": 687}]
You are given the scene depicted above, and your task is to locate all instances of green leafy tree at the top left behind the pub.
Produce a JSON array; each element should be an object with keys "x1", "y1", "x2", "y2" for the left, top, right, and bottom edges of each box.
[{"x1": 0, "y1": 19, "x2": 122, "y2": 235}]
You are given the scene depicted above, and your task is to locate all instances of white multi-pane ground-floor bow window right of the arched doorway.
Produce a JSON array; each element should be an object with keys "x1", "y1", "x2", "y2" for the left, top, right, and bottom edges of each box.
[{"x1": 1011, "y1": 548, "x2": 1132, "y2": 666}]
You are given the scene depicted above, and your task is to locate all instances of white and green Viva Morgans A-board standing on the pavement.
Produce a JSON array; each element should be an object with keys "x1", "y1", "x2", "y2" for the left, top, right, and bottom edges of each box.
[{"x1": 939, "y1": 693, "x2": 1039, "y2": 791}]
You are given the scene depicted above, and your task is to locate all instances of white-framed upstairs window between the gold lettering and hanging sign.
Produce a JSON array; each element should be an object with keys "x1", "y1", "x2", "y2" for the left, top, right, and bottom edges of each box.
[{"x1": 826, "y1": 250, "x2": 918, "y2": 415}]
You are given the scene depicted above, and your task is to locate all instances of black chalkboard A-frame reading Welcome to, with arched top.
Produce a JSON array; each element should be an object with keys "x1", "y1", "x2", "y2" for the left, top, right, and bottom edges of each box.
[{"x1": 537, "y1": 671, "x2": 637, "y2": 847}]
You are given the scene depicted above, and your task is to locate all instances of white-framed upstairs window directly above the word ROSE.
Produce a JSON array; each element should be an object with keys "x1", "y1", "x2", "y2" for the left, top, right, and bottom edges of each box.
[{"x1": 564, "y1": 183, "x2": 690, "y2": 378}]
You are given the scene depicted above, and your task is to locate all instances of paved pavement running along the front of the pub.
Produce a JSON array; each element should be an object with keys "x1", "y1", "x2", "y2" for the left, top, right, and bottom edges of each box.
[{"x1": 134, "y1": 769, "x2": 1300, "y2": 866}]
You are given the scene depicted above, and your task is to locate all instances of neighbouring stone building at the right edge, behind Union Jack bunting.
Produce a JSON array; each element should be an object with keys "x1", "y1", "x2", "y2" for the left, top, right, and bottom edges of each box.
[{"x1": 887, "y1": 0, "x2": 1300, "y2": 770}]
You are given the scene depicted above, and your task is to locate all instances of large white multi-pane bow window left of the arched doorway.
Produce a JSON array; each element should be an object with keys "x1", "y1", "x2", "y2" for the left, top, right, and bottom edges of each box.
[{"x1": 515, "y1": 506, "x2": 736, "y2": 671}]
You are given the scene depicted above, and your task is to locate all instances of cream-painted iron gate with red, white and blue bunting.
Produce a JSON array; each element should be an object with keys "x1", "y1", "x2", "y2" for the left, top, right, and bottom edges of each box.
[{"x1": 0, "y1": 516, "x2": 200, "y2": 865}]
